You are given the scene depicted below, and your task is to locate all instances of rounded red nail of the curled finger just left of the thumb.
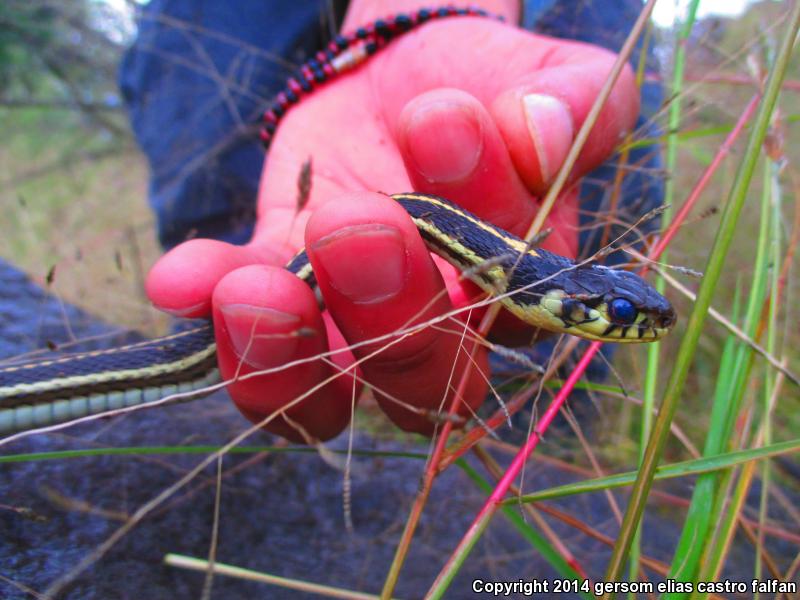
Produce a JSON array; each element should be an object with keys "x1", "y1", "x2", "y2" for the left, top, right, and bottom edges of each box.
[{"x1": 406, "y1": 101, "x2": 483, "y2": 183}]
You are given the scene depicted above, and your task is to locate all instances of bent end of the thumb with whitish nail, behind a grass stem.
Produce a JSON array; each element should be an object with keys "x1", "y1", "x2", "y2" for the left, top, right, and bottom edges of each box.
[{"x1": 490, "y1": 44, "x2": 639, "y2": 194}]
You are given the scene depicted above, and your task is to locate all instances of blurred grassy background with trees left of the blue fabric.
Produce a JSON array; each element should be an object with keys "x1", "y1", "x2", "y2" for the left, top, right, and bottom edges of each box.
[{"x1": 0, "y1": 0, "x2": 163, "y2": 333}]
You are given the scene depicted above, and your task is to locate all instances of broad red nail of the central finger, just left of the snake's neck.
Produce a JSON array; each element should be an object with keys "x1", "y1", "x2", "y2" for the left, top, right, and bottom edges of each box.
[{"x1": 312, "y1": 224, "x2": 406, "y2": 304}]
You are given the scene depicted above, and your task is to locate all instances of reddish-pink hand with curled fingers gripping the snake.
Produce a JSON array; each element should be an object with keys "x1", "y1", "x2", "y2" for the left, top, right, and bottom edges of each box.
[{"x1": 147, "y1": 15, "x2": 639, "y2": 441}]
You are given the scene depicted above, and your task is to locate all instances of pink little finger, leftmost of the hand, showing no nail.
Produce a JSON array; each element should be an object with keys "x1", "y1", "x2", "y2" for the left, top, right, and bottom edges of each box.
[{"x1": 145, "y1": 239, "x2": 284, "y2": 318}]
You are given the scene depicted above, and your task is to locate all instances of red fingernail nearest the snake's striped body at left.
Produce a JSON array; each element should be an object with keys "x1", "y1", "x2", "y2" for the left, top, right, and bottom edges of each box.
[{"x1": 220, "y1": 304, "x2": 304, "y2": 369}]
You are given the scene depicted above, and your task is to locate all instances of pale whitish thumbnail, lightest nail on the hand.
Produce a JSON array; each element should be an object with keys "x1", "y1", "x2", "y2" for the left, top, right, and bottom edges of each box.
[{"x1": 522, "y1": 94, "x2": 575, "y2": 183}]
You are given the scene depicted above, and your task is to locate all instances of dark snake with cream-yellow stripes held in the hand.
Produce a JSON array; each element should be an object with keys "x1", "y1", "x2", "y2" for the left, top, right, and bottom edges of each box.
[{"x1": 0, "y1": 193, "x2": 676, "y2": 434}]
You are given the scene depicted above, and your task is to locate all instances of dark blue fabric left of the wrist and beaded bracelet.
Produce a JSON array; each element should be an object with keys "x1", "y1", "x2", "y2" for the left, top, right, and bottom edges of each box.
[{"x1": 120, "y1": 0, "x2": 335, "y2": 248}]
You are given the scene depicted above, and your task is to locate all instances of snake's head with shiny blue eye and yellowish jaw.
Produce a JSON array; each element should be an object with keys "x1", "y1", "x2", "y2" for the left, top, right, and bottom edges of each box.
[{"x1": 540, "y1": 265, "x2": 676, "y2": 342}]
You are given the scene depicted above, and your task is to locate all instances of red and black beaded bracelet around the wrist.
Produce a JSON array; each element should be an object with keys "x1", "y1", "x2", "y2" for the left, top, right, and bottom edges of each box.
[{"x1": 259, "y1": 6, "x2": 504, "y2": 148}]
